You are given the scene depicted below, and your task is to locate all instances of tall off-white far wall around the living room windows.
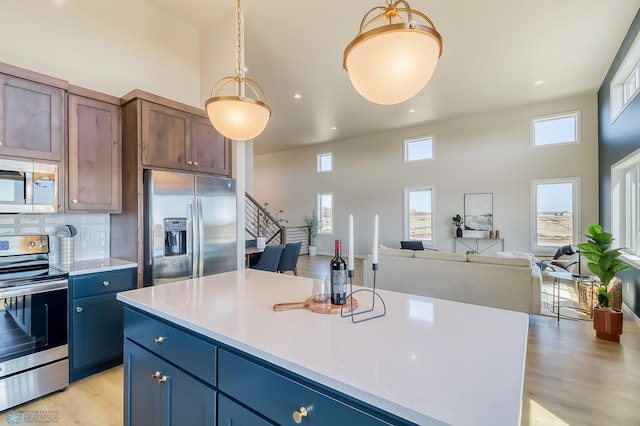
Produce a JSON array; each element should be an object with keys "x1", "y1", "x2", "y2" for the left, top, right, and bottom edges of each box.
[{"x1": 254, "y1": 93, "x2": 598, "y2": 256}]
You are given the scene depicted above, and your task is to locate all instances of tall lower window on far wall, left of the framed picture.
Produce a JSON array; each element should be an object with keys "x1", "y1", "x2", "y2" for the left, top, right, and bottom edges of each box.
[{"x1": 403, "y1": 187, "x2": 433, "y2": 243}]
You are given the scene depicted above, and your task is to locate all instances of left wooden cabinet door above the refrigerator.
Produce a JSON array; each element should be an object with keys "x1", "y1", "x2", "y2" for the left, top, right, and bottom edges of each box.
[{"x1": 142, "y1": 101, "x2": 190, "y2": 170}]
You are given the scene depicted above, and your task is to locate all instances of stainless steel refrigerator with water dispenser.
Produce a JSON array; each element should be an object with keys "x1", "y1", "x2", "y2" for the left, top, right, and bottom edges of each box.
[{"x1": 144, "y1": 170, "x2": 237, "y2": 286}]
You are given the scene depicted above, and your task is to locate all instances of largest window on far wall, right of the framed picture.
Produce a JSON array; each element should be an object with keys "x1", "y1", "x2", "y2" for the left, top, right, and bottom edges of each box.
[{"x1": 531, "y1": 177, "x2": 580, "y2": 252}]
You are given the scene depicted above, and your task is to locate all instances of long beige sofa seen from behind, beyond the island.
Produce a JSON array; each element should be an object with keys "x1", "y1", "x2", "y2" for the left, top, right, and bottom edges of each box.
[{"x1": 363, "y1": 248, "x2": 542, "y2": 314}]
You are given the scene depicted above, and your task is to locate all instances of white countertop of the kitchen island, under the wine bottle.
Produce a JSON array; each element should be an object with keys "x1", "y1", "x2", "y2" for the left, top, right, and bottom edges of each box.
[{"x1": 117, "y1": 270, "x2": 529, "y2": 425}]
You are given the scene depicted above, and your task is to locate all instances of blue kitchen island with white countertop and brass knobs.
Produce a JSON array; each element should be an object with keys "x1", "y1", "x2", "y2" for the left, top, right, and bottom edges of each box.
[{"x1": 117, "y1": 270, "x2": 528, "y2": 425}]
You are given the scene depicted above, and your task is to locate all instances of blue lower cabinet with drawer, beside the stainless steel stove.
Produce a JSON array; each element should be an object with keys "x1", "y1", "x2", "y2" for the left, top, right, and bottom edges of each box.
[{"x1": 69, "y1": 268, "x2": 136, "y2": 381}]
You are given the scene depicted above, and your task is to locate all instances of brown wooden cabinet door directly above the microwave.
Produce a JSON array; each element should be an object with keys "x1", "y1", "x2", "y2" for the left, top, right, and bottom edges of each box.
[{"x1": 0, "y1": 74, "x2": 64, "y2": 161}]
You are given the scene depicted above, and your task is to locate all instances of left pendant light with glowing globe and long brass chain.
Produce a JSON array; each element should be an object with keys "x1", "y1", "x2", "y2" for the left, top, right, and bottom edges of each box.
[{"x1": 204, "y1": 0, "x2": 271, "y2": 141}]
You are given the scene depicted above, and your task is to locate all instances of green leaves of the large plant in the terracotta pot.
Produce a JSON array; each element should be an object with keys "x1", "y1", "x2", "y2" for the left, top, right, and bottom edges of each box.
[{"x1": 578, "y1": 224, "x2": 630, "y2": 307}]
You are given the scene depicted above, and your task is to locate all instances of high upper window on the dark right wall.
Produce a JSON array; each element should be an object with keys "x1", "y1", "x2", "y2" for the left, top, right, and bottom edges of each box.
[{"x1": 609, "y1": 33, "x2": 640, "y2": 123}]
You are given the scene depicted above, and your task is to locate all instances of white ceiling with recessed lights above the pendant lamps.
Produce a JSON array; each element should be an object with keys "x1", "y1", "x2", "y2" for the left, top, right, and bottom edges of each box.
[{"x1": 146, "y1": 0, "x2": 640, "y2": 154}]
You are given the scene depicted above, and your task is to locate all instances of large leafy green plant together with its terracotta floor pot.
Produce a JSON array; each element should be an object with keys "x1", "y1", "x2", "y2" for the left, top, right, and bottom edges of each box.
[{"x1": 578, "y1": 224, "x2": 630, "y2": 342}]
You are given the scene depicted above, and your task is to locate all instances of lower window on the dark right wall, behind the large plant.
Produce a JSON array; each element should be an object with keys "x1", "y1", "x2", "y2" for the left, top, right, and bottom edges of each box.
[{"x1": 611, "y1": 149, "x2": 640, "y2": 256}]
